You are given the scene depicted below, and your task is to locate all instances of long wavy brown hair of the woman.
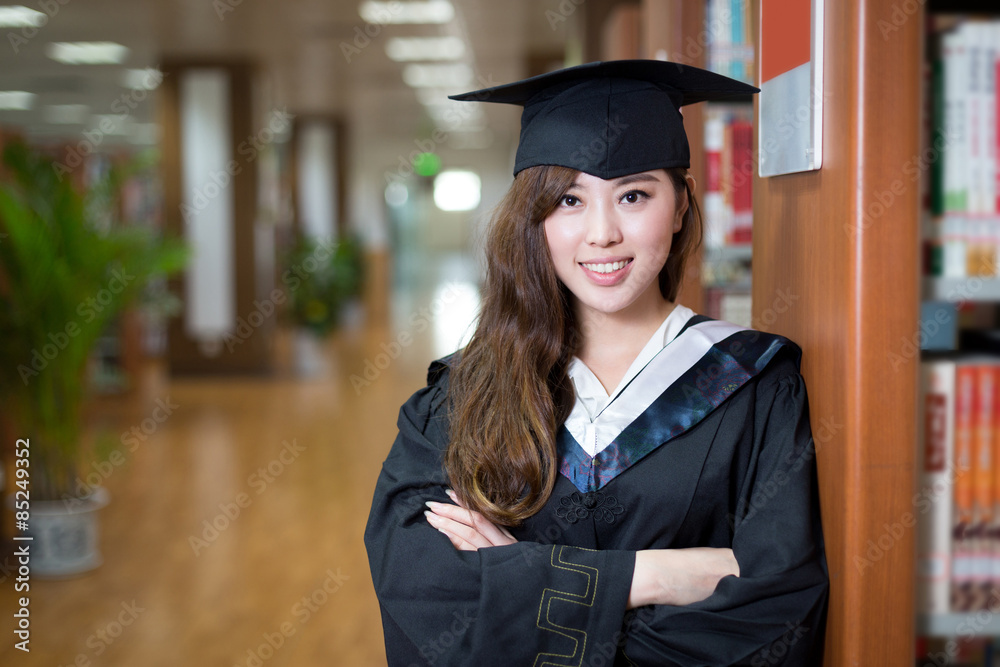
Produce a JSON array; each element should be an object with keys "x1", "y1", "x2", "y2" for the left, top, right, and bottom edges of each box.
[{"x1": 444, "y1": 166, "x2": 702, "y2": 526}]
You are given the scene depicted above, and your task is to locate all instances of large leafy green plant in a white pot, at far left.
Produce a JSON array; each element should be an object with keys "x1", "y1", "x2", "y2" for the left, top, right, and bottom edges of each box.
[{"x1": 0, "y1": 142, "x2": 187, "y2": 575}]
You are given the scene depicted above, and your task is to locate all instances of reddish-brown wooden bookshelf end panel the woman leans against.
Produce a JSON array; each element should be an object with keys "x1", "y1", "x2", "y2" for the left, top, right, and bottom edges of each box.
[{"x1": 753, "y1": 0, "x2": 924, "y2": 667}]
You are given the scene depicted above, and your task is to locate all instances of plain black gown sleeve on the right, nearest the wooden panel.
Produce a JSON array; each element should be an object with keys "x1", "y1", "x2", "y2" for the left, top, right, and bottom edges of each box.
[{"x1": 615, "y1": 362, "x2": 828, "y2": 667}]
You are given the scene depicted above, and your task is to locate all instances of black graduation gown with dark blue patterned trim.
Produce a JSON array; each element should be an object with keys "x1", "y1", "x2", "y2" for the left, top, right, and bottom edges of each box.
[{"x1": 365, "y1": 317, "x2": 828, "y2": 667}]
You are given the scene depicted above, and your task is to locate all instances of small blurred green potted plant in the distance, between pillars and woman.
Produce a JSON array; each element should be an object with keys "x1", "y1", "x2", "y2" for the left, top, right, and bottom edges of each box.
[{"x1": 283, "y1": 237, "x2": 364, "y2": 376}]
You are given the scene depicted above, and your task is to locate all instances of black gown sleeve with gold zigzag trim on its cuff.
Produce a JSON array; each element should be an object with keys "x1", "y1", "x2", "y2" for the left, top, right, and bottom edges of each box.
[{"x1": 365, "y1": 365, "x2": 635, "y2": 667}]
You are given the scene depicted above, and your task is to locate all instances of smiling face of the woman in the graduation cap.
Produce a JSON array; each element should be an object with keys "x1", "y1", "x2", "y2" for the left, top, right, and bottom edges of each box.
[{"x1": 544, "y1": 169, "x2": 687, "y2": 316}]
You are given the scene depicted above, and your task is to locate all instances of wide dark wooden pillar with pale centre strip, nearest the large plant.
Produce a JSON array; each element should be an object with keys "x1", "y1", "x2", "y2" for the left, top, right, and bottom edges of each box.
[{"x1": 157, "y1": 61, "x2": 278, "y2": 374}]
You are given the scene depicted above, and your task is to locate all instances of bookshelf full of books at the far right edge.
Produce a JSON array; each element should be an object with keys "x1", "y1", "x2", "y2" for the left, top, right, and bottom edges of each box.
[{"x1": 916, "y1": 7, "x2": 1000, "y2": 667}]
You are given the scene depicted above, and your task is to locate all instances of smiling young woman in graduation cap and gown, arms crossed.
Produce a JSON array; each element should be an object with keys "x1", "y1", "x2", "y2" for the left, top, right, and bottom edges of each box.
[{"x1": 365, "y1": 61, "x2": 828, "y2": 666}]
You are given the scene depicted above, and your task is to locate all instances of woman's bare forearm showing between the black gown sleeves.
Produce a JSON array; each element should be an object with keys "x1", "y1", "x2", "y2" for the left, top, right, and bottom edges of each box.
[{"x1": 628, "y1": 547, "x2": 740, "y2": 609}]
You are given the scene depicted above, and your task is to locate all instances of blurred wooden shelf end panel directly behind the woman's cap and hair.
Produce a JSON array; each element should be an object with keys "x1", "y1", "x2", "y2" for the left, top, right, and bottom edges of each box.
[{"x1": 642, "y1": 0, "x2": 706, "y2": 313}]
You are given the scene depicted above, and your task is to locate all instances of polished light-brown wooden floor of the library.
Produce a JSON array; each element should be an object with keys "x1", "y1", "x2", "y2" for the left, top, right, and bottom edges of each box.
[{"x1": 0, "y1": 303, "x2": 458, "y2": 667}]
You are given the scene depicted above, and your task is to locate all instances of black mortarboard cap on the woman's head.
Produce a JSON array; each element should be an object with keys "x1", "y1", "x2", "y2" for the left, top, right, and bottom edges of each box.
[{"x1": 451, "y1": 60, "x2": 759, "y2": 179}]
